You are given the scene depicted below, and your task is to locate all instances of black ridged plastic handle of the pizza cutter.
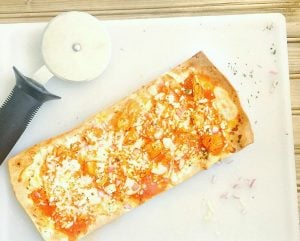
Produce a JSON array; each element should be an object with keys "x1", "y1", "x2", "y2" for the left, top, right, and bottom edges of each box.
[{"x1": 0, "y1": 67, "x2": 60, "y2": 165}]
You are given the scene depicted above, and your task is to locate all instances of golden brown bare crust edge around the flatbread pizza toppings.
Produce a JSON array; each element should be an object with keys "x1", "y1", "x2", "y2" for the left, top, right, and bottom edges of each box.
[{"x1": 8, "y1": 52, "x2": 253, "y2": 241}]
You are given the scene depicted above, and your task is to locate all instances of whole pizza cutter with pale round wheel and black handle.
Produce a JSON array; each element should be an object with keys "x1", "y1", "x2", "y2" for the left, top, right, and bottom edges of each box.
[{"x1": 0, "y1": 12, "x2": 111, "y2": 164}]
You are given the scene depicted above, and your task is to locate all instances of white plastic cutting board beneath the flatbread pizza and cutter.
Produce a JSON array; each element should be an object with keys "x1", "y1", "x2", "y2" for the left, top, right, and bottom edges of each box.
[{"x1": 0, "y1": 14, "x2": 299, "y2": 241}]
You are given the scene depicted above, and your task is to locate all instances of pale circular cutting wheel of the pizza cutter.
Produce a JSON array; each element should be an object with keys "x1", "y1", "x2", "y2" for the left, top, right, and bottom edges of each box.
[{"x1": 42, "y1": 12, "x2": 111, "y2": 81}]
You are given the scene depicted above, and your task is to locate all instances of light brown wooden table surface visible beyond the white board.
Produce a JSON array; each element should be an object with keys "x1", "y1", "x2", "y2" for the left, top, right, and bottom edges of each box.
[{"x1": 0, "y1": 0, "x2": 300, "y2": 215}]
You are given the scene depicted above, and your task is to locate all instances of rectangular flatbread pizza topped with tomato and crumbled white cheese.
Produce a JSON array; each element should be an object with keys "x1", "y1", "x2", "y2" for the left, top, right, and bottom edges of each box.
[{"x1": 9, "y1": 52, "x2": 253, "y2": 241}]
